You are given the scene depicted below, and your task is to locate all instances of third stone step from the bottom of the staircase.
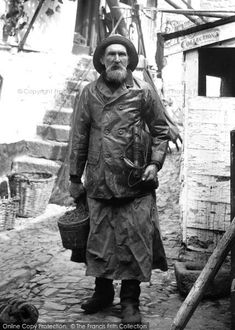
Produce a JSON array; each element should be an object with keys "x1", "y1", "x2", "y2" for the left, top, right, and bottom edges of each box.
[{"x1": 37, "y1": 124, "x2": 70, "y2": 142}]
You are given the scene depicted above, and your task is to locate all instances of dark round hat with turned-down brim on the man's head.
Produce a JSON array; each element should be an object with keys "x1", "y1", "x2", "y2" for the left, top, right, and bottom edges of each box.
[{"x1": 93, "y1": 34, "x2": 139, "y2": 73}]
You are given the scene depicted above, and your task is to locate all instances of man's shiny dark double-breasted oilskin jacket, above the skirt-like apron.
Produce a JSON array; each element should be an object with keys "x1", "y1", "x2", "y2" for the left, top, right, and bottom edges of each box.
[{"x1": 70, "y1": 72, "x2": 169, "y2": 199}]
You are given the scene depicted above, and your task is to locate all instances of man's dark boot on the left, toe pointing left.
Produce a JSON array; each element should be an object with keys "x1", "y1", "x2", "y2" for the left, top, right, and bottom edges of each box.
[{"x1": 81, "y1": 277, "x2": 114, "y2": 314}]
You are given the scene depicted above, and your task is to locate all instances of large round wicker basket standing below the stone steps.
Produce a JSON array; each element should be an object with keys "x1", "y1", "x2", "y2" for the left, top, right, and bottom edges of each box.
[{"x1": 9, "y1": 172, "x2": 55, "y2": 218}]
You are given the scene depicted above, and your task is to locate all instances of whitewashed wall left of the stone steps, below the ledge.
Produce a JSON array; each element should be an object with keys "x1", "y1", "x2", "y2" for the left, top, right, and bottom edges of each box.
[{"x1": 0, "y1": 52, "x2": 79, "y2": 143}]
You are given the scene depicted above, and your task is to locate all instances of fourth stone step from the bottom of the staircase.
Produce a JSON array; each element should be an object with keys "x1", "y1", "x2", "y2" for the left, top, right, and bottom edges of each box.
[{"x1": 43, "y1": 108, "x2": 73, "y2": 125}]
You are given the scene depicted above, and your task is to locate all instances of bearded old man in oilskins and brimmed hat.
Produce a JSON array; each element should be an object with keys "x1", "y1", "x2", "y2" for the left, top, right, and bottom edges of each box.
[{"x1": 70, "y1": 35, "x2": 169, "y2": 323}]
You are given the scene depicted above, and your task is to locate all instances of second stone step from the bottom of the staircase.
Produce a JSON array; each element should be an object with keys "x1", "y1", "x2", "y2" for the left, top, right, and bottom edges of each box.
[{"x1": 25, "y1": 139, "x2": 68, "y2": 161}]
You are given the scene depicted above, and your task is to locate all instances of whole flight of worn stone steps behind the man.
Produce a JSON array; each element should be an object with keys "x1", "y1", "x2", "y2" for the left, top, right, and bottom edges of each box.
[{"x1": 12, "y1": 57, "x2": 92, "y2": 203}]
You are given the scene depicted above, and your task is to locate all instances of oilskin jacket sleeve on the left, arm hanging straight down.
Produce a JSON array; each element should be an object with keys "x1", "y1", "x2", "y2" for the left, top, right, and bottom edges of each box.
[{"x1": 70, "y1": 87, "x2": 90, "y2": 182}]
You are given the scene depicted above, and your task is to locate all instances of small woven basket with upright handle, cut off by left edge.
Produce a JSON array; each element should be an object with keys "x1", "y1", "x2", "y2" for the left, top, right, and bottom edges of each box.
[{"x1": 0, "y1": 180, "x2": 19, "y2": 231}]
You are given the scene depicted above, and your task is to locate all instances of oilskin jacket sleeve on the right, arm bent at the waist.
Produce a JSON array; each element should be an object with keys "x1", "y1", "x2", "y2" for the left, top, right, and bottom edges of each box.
[{"x1": 142, "y1": 86, "x2": 170, "y2": 170}]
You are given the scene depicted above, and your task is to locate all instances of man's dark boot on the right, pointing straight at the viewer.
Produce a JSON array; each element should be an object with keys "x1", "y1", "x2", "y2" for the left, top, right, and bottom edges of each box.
[{"x1": 120, "y1": 280, "x2": 141, "y2": 324}]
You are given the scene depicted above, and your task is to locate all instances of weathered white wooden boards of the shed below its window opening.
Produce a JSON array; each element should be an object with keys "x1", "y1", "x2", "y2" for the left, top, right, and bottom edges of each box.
[{"x1": 182, "y1": 97, "x2": 235, "y2": 250}]
